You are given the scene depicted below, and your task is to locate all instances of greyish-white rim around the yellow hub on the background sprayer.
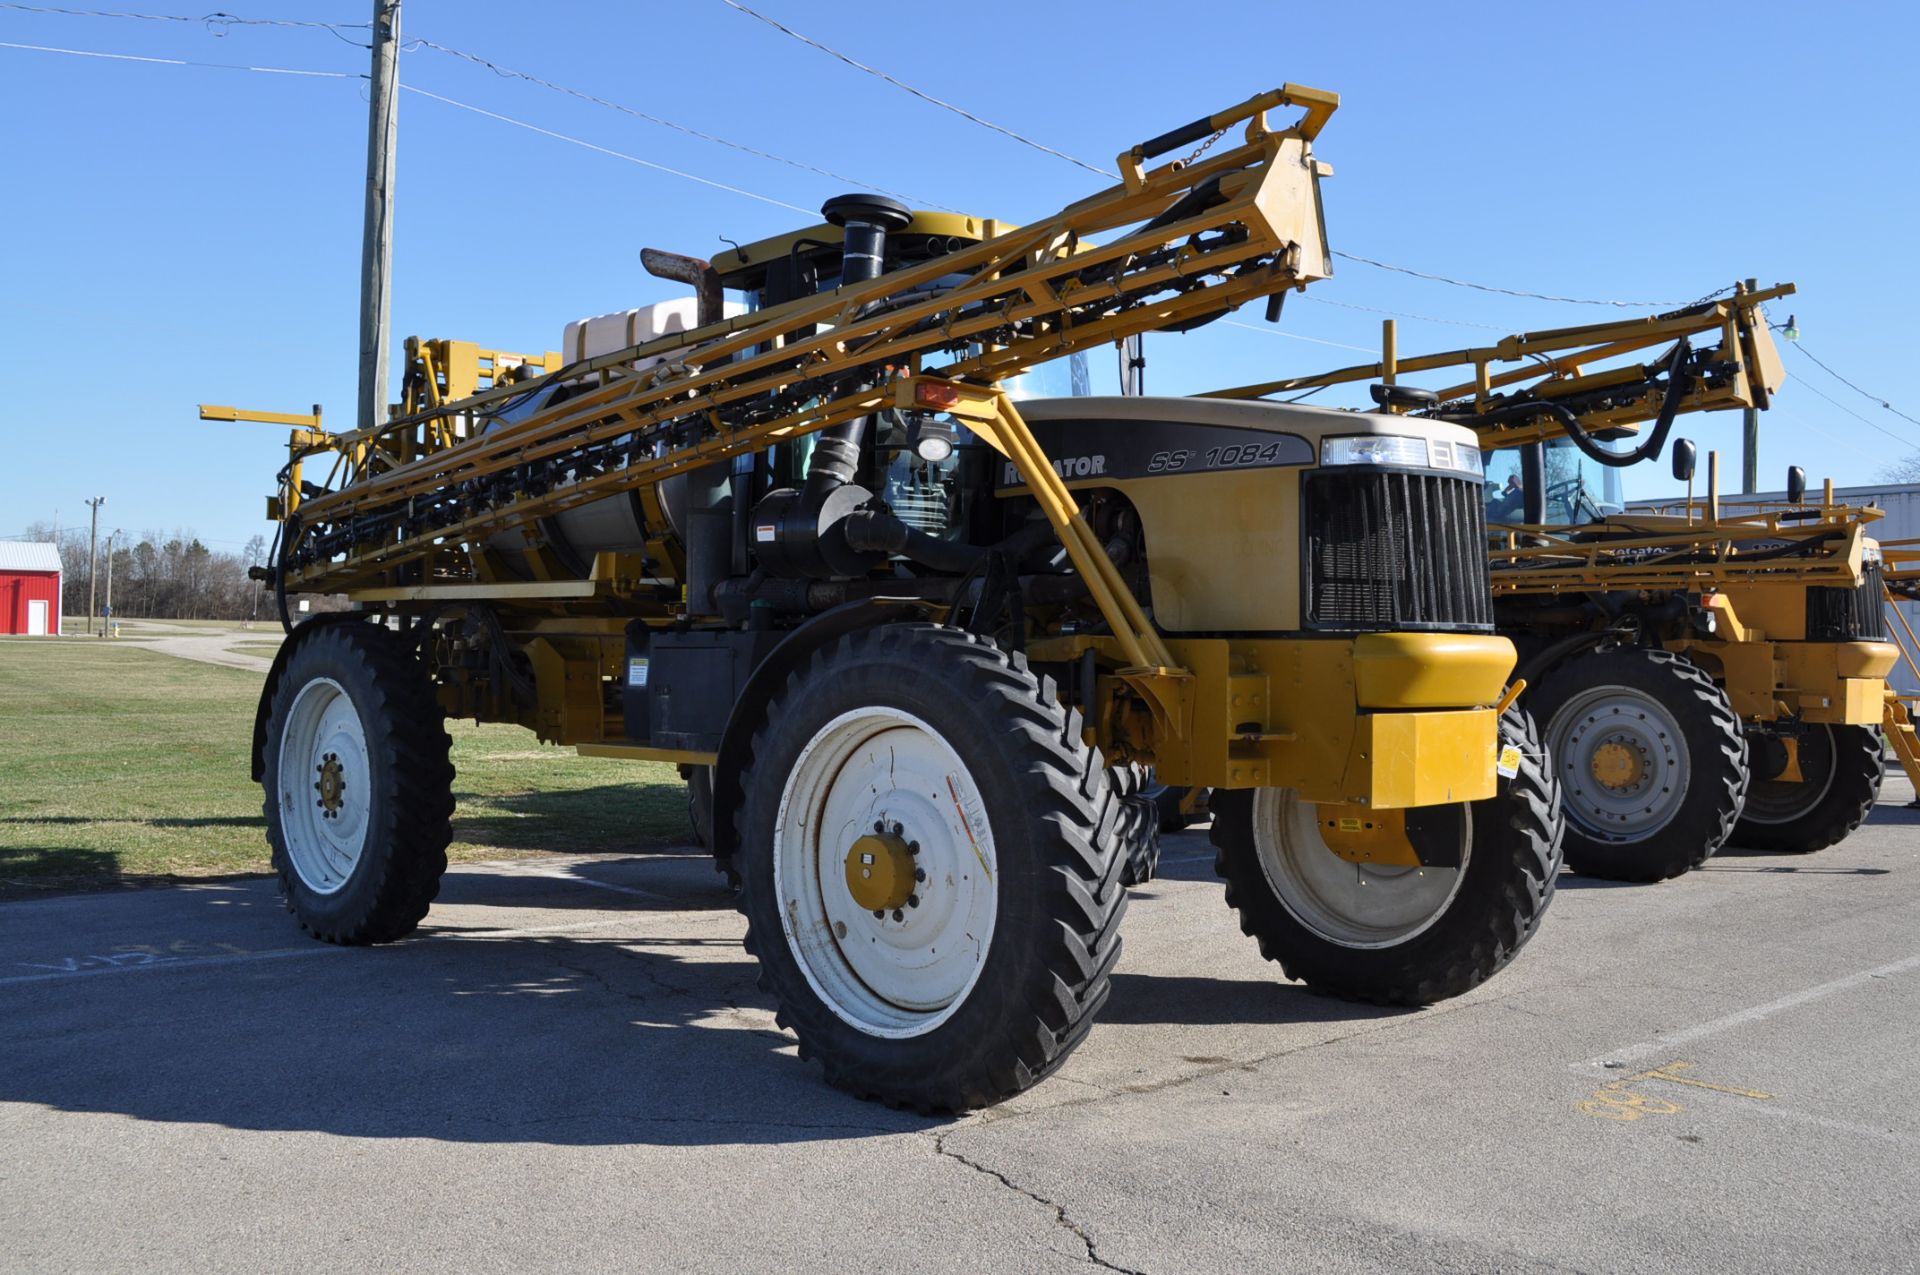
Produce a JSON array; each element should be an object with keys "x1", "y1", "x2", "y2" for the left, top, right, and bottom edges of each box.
[{"x1": 1548, "y1": 686, "x2": 1692, "y2": 841}]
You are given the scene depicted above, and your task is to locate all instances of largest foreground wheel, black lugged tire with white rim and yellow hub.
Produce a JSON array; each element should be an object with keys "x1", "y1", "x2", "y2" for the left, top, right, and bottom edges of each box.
[{"x1": 735, "y1": 624, "x2": 1125, "y2": 1112}]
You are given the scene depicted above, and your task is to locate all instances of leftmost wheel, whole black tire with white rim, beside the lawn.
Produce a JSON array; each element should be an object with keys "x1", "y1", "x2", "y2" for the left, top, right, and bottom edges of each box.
[{"x1": 263, "y1": 622, "x2": 453, "y2": 945}]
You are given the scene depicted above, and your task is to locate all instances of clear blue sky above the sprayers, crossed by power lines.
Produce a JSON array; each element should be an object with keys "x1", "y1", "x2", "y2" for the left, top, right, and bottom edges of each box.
[{"x1": 0, "y1": 0, "x2": 1920, "y2": 549}]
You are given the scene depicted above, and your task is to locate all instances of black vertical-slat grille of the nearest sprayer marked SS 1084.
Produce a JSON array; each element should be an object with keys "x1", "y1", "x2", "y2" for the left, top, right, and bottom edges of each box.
[{"x1": 1300, "y1": 469, "x2": 1494, "y2": 632}]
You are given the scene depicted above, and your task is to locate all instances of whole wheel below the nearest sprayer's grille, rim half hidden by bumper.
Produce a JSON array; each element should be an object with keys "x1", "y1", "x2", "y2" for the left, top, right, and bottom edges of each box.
[{"x1": 1212, "y1": 709, "x2": 1563, "y2": 1006}]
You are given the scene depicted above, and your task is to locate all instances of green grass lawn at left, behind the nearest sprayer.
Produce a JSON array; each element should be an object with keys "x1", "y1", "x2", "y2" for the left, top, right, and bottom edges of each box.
[{"x1": 0, "y1": 639, "x2": 689, "y2": 895}]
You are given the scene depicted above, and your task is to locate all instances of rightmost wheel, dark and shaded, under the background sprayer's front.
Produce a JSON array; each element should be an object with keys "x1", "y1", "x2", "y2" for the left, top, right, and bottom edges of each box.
[{"x1": 1734, "y1": 726, "x2": 1884, "y2": 854}]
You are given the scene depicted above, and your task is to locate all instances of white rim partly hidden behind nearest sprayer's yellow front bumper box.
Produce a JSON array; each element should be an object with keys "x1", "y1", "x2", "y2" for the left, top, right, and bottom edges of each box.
[{"x1": 1254, "y1": 787, "x2": 1473, "y2": 949}]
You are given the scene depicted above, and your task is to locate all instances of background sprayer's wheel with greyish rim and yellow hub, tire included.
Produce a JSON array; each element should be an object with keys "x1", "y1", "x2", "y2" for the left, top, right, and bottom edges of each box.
[{"x1": 1526, "y1": 647, "x2": 1747, "y2": 881}]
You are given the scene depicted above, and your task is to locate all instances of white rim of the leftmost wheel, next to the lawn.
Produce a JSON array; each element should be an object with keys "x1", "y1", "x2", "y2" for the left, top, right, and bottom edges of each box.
[{"x1": 276, "y1": 678, "x2": 372, "y2": 895}]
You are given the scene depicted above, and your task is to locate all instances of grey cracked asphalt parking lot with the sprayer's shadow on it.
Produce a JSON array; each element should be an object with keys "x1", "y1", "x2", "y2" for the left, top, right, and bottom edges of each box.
[{"x1": 0, "y1": 780, "x2": 1920, "y2": 1273}]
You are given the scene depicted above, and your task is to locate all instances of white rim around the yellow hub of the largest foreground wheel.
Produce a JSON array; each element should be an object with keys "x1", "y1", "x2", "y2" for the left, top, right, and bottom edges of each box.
[{"x1": 772, "y1": 707, "x2": 1000, "y2": 1039}]
